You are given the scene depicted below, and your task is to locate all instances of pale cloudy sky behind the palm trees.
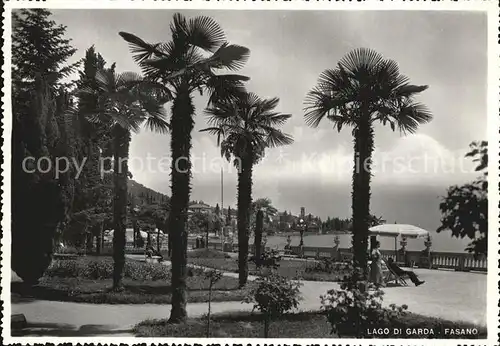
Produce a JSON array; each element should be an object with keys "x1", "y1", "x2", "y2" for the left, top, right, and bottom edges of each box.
[{"x1": 48, "y1": 9, "x2": 487, "y2": 249}]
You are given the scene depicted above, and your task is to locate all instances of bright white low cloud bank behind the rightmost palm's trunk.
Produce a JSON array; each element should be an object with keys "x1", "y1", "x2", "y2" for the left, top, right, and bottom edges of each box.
[{"x1": 252, "y1": 134, "x2": 477, "y2": 185}]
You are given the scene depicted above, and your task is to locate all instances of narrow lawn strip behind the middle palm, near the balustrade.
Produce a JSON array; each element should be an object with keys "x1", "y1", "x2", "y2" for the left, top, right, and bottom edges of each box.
[{"x1": 188, "y1": 257, "x2": 346, "y2": 281}]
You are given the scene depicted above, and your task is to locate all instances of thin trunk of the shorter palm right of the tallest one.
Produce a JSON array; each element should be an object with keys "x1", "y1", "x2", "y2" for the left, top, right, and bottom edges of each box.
[{"x1": 238, "y1": 155, "x2": 252, "y2": 287}]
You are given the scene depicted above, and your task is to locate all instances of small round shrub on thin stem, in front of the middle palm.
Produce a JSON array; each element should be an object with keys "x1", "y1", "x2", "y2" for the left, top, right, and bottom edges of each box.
[{"x1": 244, "y1": 272, "x2": 302, "y2": 338}]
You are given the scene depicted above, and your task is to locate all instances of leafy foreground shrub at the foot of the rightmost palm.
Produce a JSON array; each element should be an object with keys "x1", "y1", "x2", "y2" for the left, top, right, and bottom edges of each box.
[{"x1": 320, "y1": 268, "x2": 408, "y2": 338}]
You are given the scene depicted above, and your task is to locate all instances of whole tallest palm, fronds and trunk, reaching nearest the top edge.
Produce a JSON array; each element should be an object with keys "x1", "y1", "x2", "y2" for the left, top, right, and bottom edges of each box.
[{"x1": 120, "y1": 14, "x2": 250, "y2": 323}]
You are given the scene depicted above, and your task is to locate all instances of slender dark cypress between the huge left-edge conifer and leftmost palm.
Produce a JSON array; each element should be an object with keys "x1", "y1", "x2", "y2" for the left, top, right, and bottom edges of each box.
[{"x1": 65, "y1": 46, "x2": 112, "y2": 252}]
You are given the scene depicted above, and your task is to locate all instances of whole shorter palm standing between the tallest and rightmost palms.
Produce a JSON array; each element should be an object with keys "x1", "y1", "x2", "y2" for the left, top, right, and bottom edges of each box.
[{"x1": 202, "y1": 93, "x2": 293, "y2": 287}]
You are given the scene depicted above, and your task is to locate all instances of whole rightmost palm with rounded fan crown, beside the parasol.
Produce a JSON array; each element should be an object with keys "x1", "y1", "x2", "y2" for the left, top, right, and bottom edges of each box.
[{"x1": 305, "y1": 48, "x2": 432, "y2": 274}]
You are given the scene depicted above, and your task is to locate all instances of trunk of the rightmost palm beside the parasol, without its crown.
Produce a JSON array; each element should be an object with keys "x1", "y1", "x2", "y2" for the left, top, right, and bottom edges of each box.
[{"x1": 352, "y1": 116, "x2": 373, "y2": 278}]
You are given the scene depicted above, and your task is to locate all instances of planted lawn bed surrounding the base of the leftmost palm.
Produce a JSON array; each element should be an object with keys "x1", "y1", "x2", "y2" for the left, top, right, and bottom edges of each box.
[{"x1": 11, "y1": 257, "x2": 246, "y2": 304}]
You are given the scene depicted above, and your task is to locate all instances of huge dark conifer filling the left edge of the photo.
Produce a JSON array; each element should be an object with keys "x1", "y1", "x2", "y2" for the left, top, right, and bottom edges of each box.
[{"x1": 11, "y1": 9, "x2": 76, "y2": 283}]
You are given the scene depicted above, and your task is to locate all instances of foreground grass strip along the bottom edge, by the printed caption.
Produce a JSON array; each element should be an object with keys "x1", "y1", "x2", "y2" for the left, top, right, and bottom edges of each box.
[{"x1": 134, "y1": 312, "x2": 487, "y2": 339}]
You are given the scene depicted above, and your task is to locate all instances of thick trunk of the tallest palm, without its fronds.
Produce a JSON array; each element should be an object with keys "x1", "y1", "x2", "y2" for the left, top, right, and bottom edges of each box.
[{"x1": 168, "y1": 87, "x2": 194, "y2": 323}]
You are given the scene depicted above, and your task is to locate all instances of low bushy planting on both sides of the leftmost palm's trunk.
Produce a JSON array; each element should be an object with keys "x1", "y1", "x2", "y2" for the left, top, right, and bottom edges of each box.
[{"x1": 44, "y1": 257, "x2": 171, "y2": 281}]
